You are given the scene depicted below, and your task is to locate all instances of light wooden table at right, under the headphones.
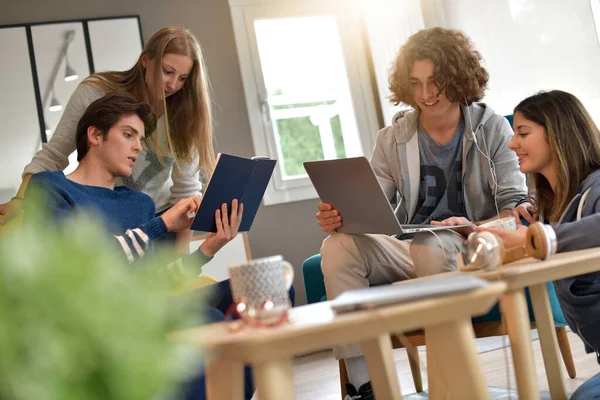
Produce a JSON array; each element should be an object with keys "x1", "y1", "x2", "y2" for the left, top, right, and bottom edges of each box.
[{"x1": 475, "y1": 248, "x2": 600, "y2": 400}]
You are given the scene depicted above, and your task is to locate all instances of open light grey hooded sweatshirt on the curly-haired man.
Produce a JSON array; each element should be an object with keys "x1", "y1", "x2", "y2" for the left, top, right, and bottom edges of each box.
[{"x1": 371, "y1": 103, "x2": 527, "y2": 224}]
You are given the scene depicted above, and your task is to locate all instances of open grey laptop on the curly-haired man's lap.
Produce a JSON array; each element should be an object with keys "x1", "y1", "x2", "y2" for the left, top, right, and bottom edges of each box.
[{"x1": 304, "y1": 157, "x2": 469, "y2": 235}]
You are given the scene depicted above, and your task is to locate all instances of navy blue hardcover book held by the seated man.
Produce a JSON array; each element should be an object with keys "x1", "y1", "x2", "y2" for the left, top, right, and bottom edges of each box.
[{"x1": 191, "y1": 153, "x2": 277, "y2": 232}]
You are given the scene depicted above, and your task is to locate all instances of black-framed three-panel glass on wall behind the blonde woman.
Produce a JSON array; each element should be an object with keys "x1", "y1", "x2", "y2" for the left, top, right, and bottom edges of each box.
[{"x1": 0, "y1": 15, "x2": 144, "y2": 181}]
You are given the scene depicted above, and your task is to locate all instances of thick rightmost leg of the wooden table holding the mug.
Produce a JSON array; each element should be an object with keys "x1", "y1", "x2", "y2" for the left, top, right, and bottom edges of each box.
[{"x1": 425, "y1": 318, "x2": 490, "y2": 400}]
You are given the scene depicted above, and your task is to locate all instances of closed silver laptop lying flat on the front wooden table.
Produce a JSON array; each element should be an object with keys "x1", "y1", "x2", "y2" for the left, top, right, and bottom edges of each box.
[{"x1": 331, "y1": 274, "x2": 488, "y2": 313}]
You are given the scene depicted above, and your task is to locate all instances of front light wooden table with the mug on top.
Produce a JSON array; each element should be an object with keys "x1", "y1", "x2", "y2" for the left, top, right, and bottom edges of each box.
[{"x1": 170, "y1": 282, "x2": 506, "y2": 400}]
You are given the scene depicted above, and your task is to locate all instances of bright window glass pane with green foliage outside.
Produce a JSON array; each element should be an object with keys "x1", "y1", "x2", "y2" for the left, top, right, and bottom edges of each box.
[{"x1": 254, "y1": 16, "x2": 362, "y2": 179}]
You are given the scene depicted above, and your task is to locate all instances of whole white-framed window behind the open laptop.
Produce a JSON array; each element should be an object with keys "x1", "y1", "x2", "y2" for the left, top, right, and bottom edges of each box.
[{"x1": 230, "y1": 0, "x2": 379, "y2": 205}]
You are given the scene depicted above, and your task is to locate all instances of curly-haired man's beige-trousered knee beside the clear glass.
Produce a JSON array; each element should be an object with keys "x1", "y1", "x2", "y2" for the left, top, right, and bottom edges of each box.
[{"x1": 410, "y1": 232, "x2": 458, "y2": 277}]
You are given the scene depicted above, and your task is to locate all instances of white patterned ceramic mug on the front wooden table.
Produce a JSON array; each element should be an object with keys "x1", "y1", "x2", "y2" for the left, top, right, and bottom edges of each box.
[{"x1": 229, "y1": 256, "x2": 294, "y2": 322}]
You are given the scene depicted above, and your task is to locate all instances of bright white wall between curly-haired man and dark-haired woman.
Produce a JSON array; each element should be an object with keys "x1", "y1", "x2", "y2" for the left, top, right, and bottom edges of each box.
[{"x1": 437, "y1": 0, "x2": 600, "y2": 124}]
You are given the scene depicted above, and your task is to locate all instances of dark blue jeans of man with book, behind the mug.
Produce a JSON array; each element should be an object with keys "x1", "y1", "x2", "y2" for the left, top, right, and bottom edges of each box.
[{"x1": 176, "y1": 279, "x2": 296, "y2": 400}]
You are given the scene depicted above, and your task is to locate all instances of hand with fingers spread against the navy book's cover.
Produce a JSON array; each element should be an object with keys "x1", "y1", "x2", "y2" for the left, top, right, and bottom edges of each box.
[{"x1": 200, "y1": 199, "x2": 244, "y2": 257}]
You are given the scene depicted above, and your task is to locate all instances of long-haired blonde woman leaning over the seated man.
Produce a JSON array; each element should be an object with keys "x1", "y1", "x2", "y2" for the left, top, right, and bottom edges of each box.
[{"x1": 0, "y1": 27, "x2": 234, "y2": 256}]
